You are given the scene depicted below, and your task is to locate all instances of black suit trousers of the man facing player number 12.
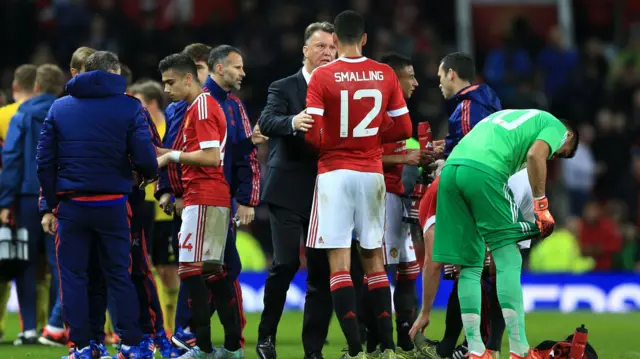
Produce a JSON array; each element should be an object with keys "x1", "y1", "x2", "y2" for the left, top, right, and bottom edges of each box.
[{"x1": 258, "y1": 204, "x2": 333, "y2": 354}]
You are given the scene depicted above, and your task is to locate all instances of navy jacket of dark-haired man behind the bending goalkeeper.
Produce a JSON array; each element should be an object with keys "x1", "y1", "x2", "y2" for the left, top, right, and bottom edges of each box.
[{"x1": 444, "y1": 84, "x2": 502, "y2": 157}]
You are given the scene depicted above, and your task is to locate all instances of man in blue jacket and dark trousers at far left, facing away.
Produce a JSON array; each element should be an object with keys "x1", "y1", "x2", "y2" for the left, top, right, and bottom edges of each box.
[{"x1": 0, "y1": 64, "x2": 64, "y2": 344}]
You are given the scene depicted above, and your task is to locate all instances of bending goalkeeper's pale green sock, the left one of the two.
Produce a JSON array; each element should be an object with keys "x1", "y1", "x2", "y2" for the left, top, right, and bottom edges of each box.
[{"x1": 458, "y1": 267, "x2": 485, "y2": 355}]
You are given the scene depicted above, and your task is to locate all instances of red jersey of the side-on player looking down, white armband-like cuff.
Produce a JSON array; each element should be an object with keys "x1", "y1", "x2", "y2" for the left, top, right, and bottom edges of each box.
[{"x1": 181, "y1": 93, "x2": 231, "y2": 207}]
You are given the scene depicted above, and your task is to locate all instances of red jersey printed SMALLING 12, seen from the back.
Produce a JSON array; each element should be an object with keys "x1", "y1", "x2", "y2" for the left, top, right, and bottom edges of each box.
[{"x1": 306, "y1": 57, "x2": 409, "y2": 173}]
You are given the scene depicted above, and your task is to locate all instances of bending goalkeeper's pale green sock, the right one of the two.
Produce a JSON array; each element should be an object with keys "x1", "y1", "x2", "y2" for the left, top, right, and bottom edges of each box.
[{"x1": 491, "y1": 243, "x2": 529, "y2": 356}]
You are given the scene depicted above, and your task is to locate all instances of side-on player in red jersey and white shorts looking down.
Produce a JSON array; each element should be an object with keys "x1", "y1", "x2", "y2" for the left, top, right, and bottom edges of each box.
[{"x1": 158, "y1": 53, "x2": 231, "y2": 359}]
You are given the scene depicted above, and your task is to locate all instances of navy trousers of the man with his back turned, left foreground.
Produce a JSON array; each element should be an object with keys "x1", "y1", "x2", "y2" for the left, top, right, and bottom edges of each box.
[{"x1": 57, "y1": 201, "x2": 142, "y2": 348}]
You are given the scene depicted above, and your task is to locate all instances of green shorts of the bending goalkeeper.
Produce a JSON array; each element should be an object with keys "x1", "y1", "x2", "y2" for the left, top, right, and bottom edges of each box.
[{"x1": 433, "y1": 165, "x2": 539, "y2": 266}]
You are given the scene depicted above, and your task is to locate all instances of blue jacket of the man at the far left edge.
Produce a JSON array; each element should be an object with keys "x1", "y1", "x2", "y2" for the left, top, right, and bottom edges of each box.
[{"x1": 0, "y1": 94, "x2": 57, "y2": 208}]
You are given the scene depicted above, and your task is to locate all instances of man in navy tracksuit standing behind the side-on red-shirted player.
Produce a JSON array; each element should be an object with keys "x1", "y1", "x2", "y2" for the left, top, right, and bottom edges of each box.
[{"x1": 198, "y1": 45, "x2": 260, "y2": 358}]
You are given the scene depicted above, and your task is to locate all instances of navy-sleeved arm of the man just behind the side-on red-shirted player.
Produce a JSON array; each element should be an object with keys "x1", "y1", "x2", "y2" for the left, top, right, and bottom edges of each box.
[{"x1": 230, "y1": 96, "x2": 260, "y2": 207}]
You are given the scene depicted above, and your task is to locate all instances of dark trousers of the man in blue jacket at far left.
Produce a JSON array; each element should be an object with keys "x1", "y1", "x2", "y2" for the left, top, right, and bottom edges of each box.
[{"x1": 15, "y1": 196, "x2": 59, "y2": 331}]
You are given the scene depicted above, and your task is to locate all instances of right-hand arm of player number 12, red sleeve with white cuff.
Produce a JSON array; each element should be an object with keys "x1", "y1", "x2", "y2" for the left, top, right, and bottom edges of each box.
[{"x1": 381, "y1": 71, "x2": 413, "y2": 143}]
